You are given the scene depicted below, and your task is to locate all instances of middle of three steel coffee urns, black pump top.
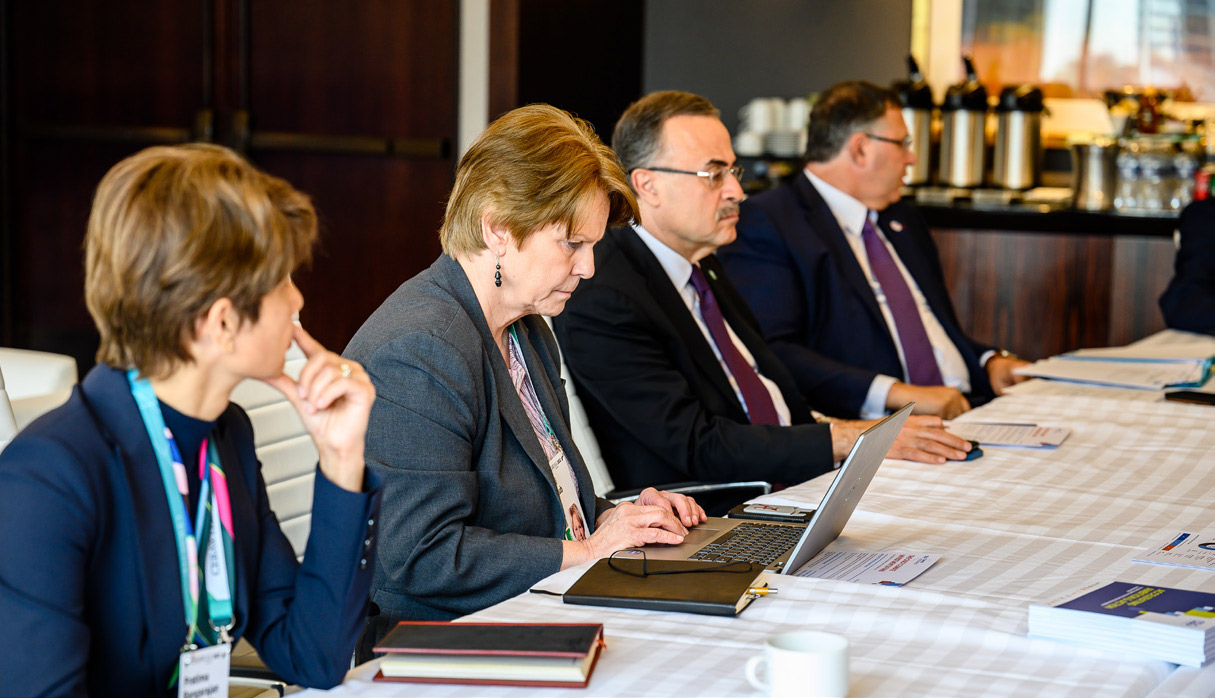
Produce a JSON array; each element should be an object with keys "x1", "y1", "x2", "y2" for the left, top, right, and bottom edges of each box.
[{"x1": 940, "y1": 56, "x2": 987, "y2": 187}]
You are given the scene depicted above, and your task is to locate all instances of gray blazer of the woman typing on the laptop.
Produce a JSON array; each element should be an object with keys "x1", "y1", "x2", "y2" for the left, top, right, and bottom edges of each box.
[{"x1": 344, "y1": 255, "x2": 611, "y2": 637}]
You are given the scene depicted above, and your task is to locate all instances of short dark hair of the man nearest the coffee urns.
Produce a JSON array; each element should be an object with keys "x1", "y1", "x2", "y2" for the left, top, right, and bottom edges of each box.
[{"x1": 804, "y1": 80, "x2": 903, "y2": 163}]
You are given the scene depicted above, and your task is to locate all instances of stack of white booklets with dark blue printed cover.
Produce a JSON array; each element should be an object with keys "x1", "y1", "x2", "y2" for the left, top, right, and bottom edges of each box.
[{"x1": 1029, "y1": 581, "x2": 1215, "y2": 666}]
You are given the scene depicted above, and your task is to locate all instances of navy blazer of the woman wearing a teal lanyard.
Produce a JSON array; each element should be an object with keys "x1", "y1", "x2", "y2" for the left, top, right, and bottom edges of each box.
[{"x1": 0, "y1": 366, "x2": 379, "y2": 696}]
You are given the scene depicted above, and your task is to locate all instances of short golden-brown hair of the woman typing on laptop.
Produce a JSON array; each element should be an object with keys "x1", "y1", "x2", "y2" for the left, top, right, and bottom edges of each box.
[{"x1": 439, "y1": 105, "x2": 638, "y2": 257}]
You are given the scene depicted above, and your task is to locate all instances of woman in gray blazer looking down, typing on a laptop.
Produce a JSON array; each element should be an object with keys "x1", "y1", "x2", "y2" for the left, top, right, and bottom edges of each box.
[{"x1": 345, "y1": 105, "x2": 705, "y2": 640}]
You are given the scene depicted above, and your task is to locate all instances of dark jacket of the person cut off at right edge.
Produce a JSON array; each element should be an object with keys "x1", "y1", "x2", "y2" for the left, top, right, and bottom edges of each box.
[{"x1": 1160, "y1": 198, "x2": 1215, "y2": 334}]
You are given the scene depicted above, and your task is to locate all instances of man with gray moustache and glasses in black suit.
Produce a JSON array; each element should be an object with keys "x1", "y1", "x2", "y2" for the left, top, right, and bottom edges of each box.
[{"x1": 553, "y1": 92, "x2": 970, "y2": 498}]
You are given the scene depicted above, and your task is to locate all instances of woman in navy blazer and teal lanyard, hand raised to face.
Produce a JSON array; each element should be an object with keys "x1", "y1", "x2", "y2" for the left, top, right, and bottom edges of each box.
[{"x1": 0, "y1": 145, "x2": 379, "y2": 696}]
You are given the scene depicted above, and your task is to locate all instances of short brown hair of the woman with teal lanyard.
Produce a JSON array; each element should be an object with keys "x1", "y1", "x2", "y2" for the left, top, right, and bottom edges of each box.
[{"x1": 85, "y1": 143, "x2": 317, "y2": 377}]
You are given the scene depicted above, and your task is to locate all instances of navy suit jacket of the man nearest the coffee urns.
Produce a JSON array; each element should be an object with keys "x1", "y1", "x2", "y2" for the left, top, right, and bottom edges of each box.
[{"x1": 718, "y1": 174, "x2": 995, "y2": 417}]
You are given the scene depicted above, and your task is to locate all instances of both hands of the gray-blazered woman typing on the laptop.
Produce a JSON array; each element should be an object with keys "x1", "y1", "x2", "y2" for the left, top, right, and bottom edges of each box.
[{"x1": 561, "y1": 488, "x2": 706, "y2": 569}]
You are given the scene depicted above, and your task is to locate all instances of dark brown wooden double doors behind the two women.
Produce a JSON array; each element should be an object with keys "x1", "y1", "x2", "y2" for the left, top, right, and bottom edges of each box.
[{"x1": 0, "y1": 0, "x2": 458, "y2": 368}]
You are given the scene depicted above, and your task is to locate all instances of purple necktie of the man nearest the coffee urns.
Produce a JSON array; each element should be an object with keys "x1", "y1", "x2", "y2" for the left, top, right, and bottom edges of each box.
[{"x1": 860, "y1": 215, "x2": 945, "y2": 385}]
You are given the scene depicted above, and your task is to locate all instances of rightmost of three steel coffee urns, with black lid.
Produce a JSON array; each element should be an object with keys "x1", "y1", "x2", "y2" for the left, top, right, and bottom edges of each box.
[{"x1": 991, "y1": 85, "x2": 1042, "y2": 190}]
